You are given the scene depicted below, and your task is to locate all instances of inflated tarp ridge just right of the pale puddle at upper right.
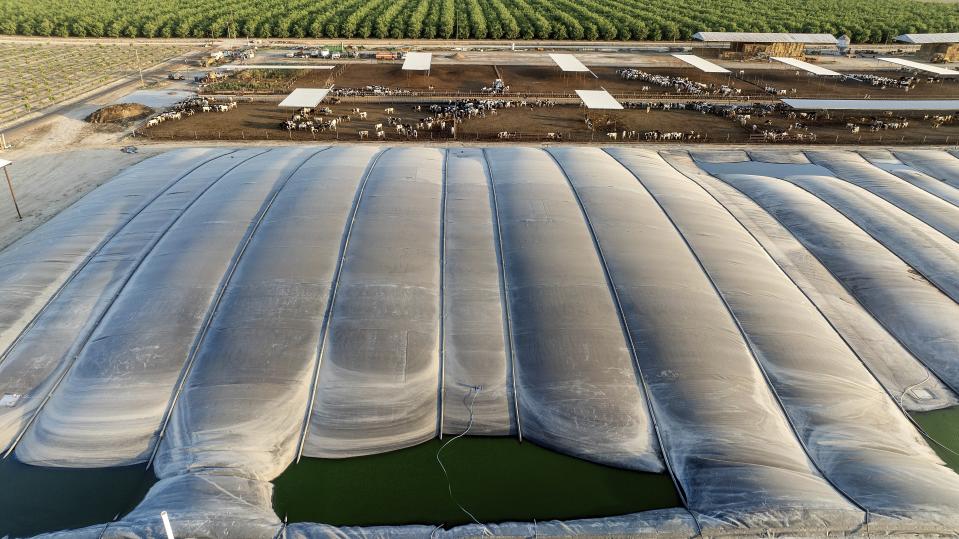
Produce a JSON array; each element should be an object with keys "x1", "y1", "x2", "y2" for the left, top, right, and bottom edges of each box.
[{"x1": 807, "y1": 150, "x2": 959, "y2": 241}]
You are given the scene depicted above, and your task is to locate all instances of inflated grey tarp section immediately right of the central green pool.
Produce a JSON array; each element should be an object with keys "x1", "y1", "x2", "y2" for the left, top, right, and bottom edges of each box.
[{"x1": 551, "y1": 148, "x2": 863, "y2": 531}]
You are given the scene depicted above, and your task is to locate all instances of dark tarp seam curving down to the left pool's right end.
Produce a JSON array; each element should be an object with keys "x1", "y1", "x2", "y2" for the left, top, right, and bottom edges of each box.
[{"x1": 147, "y1": 146, "x2": 331, "y2": 468}]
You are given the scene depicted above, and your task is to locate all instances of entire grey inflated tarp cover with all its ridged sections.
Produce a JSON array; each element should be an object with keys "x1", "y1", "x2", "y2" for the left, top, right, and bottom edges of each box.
[{"x1": 0, "y1": 145, "x2": 959, "y2": 539}]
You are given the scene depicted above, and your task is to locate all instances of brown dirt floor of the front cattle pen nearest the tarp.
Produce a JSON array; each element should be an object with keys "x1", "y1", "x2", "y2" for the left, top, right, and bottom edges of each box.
[{"x1": 141, "y1": 103, "x2": 959, "y2": 144}]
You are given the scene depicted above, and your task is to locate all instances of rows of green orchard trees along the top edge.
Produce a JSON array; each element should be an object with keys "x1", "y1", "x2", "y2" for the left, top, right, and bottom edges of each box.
[{"x1": 0, "y1": 0, "x2": 959, "y2": 43}]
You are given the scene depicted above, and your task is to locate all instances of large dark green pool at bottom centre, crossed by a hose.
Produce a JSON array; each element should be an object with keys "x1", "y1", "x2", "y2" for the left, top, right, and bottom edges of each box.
[{"x1": 273, "y1": 437, "x2": 681, "y2": 527}]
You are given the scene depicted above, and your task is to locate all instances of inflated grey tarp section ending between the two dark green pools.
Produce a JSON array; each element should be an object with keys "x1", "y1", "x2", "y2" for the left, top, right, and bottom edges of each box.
[{"x1": 155, "y1": 147, "x2": 380, "y2": 480}]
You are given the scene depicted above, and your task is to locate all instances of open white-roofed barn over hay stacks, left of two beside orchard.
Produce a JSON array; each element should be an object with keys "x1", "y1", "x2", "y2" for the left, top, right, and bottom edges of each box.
[{"x1": 693, "y1": 32, "x2": 837, "y2": 60}]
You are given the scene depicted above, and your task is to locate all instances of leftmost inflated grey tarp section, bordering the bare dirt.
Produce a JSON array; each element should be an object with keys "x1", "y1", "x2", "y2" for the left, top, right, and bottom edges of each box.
[{"x1": 0, "y1": 149, "x2": 232, "y2": 364}]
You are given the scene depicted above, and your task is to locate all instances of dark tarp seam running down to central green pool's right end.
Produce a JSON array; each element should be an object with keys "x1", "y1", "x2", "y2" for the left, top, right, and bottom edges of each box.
[{"x1": 545, "y1": 150, "x2": 702, "y2": 535}]
